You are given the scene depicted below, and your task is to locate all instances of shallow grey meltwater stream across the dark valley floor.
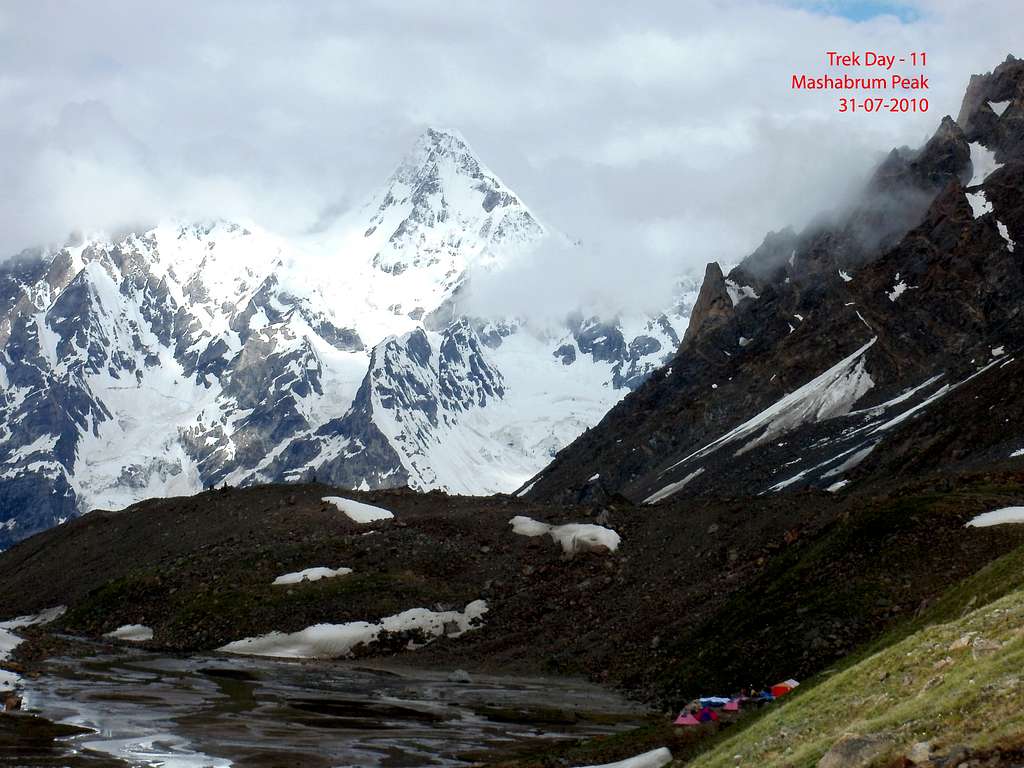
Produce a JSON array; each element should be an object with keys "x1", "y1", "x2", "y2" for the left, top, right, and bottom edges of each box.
[{"x1": 27, "y1": 649, "x2": 643, "y2": 768}]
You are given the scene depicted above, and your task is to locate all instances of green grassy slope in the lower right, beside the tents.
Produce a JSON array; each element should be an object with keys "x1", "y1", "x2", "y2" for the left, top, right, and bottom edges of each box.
[{"x1": 680, "y1": 548, "x2": 1024, "y2": 768}]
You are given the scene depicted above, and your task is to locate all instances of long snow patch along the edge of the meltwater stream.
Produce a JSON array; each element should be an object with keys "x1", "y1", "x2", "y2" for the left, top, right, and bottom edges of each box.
[{"x1": 217, "y1": 600, "x2": 487, "y2": 658}]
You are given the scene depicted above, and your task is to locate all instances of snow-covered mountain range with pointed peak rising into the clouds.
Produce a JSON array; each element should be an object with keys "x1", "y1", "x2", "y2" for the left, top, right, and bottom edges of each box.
[{"x1": 0, "y1": 129, "x2": 696, "y2": 549}]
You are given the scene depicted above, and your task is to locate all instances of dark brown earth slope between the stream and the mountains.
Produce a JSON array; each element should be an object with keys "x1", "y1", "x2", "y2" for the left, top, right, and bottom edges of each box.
[{"x1": 6, "y1": 464, "x2": 1024, "y2": 706}]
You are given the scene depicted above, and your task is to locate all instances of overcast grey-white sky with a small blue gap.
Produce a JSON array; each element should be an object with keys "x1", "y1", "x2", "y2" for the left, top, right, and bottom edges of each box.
[{"x1": 0, "y1": 0, "x2": 1024, "y2": 313}]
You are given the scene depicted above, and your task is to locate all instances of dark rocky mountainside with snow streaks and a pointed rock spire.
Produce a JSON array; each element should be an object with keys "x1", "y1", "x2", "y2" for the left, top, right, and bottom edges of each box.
[{"x1": 520, "y1": 56, "x2": 1024, "y2": 512}]
